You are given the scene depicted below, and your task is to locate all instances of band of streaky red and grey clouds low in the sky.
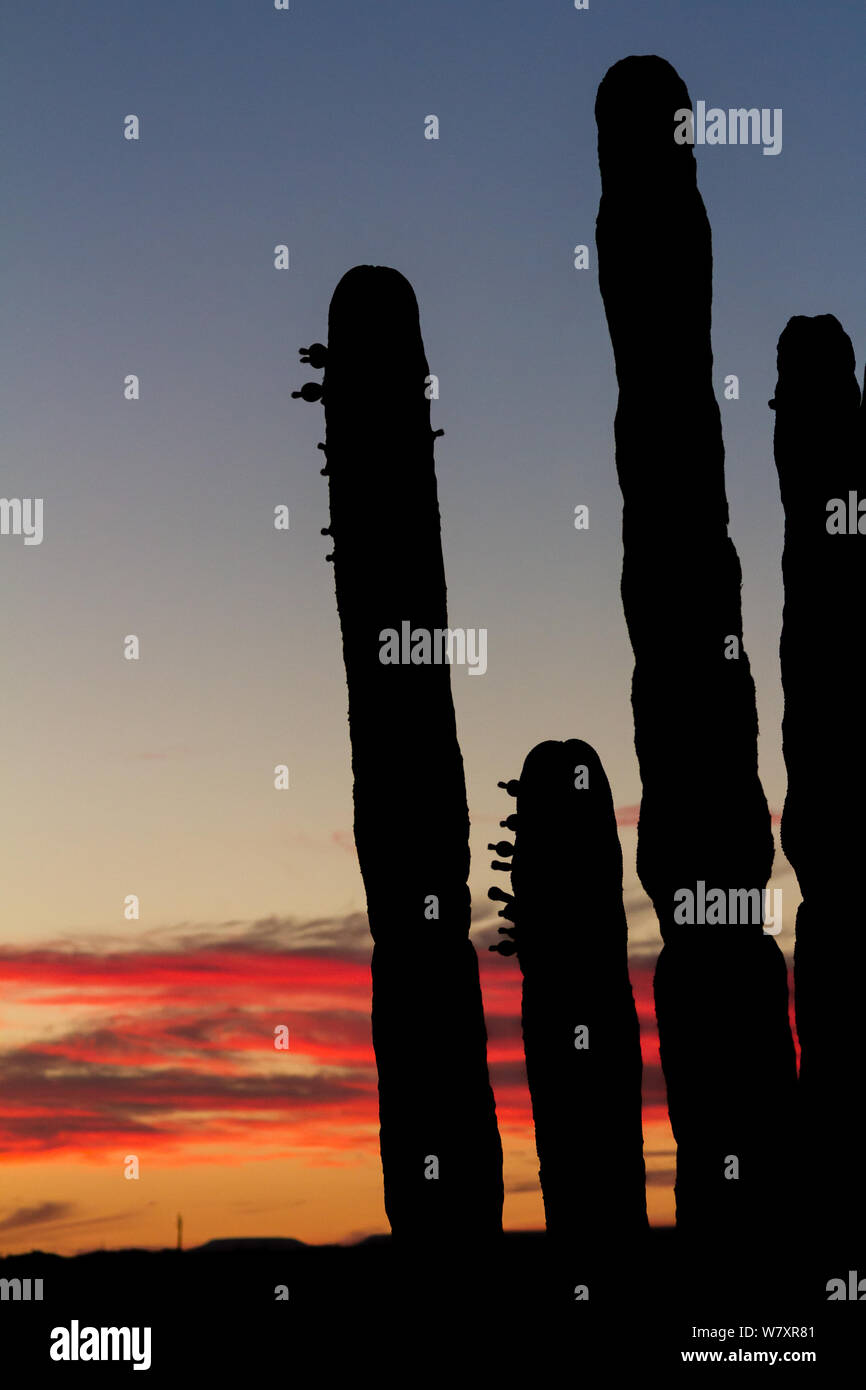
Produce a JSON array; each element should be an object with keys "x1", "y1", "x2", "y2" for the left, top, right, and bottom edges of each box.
[{"x1": 0, "y1": 916, "x2": 678, "y2": 1165}]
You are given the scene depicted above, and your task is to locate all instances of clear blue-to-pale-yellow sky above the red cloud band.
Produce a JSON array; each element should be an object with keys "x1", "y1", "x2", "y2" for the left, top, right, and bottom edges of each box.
[{"x1": 0, "y1": 0, "x2": 866, "y2": 1251}]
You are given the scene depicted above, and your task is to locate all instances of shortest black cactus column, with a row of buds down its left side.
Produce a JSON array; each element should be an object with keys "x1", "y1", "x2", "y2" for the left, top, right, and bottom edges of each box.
[{"x1": 491, "y1": 738, "x2": 646, "y2": 1255}]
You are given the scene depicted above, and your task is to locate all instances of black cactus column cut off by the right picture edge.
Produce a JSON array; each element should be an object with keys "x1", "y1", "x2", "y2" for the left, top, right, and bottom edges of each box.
[{"x1": 771, "y1": 314, "x2": 866, "y2": 1252}]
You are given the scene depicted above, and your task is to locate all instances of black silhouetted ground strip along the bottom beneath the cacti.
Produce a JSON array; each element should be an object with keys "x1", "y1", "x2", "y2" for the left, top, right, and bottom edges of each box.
[{"x1": 0, "y1": 1230, "x2": 866, "y2": 1390}]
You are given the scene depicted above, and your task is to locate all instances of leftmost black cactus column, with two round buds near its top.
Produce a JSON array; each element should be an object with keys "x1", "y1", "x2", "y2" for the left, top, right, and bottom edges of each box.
[{"x1": 296, "y1": 265, "x2": 503, "y2": 1244}]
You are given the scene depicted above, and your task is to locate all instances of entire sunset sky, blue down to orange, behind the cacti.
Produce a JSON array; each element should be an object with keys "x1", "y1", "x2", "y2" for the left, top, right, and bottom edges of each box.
[{"x1": 0, "y1": 0, "x2": 866, "y2": 1252}]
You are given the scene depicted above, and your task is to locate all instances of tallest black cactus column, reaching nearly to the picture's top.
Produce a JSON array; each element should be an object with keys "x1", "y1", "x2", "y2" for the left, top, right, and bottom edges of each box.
[{"x1": 596, "y1": 57, "x2": 795, "y2": 1236}]
